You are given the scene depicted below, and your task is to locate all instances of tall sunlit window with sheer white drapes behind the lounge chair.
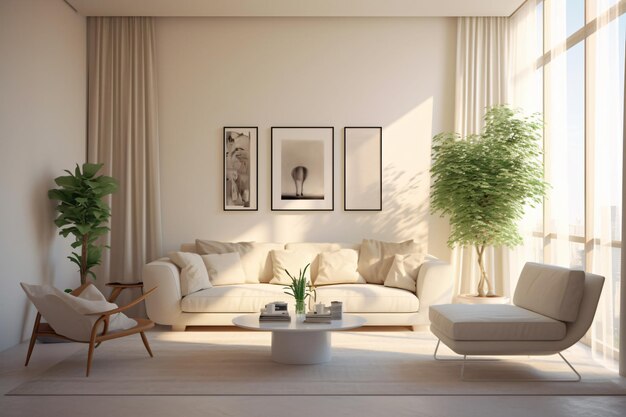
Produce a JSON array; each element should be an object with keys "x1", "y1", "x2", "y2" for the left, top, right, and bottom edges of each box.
[{"x1": 529, "y1": 0, "x2": 626, "y2": 360}]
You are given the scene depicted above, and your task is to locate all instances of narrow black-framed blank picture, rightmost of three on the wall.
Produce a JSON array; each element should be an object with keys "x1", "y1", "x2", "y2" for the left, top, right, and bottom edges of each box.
[{"x1": 343, "y1": 127, "x2": 383, "y2": 211}]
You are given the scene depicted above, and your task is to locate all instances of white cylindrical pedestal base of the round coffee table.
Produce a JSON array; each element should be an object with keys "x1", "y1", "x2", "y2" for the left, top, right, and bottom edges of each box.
[{"x1": 272, "y1": 331, "x2": 332, "y2": 365}]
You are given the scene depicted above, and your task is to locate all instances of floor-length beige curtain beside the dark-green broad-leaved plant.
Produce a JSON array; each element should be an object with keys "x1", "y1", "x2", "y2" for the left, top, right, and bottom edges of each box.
[{"x1": 87, "y1": 17, "x2": 161, "y2": 303}]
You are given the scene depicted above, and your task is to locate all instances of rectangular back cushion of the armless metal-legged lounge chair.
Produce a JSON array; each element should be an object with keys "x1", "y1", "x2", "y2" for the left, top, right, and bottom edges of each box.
[{"x1": 513, "y1": 262, "x2": 585, "y2": 322}]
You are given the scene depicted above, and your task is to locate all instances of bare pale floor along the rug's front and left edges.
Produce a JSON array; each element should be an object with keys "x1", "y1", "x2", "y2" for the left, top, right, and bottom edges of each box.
[{"x1": 0, "y1": 324, "x2": 626, "y2": 417}]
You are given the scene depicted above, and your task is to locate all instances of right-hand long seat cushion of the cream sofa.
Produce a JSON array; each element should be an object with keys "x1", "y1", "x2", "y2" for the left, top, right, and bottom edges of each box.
[{"x1": 316, "y1": 284, "x2": 419, "y2": 313}]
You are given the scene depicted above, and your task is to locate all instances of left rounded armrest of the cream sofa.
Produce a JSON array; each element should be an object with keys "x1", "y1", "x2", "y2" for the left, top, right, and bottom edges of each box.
[{"x1": 142, "y1": 258, "x2": 182, "y2": 325}]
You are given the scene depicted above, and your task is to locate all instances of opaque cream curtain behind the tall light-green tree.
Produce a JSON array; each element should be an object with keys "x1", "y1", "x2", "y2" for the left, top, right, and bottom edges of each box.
[{"x1": 452, "y1": 17, "x2": 509, "y2": 294}]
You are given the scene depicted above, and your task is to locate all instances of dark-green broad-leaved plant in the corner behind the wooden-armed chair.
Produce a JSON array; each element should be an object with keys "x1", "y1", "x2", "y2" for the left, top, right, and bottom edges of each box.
[{"x1": 48, "y1": 163, "x2": 118, "y2": 285}]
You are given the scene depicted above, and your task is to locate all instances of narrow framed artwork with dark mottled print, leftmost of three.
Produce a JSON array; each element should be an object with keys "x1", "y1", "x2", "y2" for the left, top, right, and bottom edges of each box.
[{"x1": 223, "y1": 127, "x2": 259, "y2": 211}]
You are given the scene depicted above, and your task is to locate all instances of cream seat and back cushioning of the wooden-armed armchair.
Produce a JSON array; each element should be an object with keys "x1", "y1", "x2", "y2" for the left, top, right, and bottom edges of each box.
[{"x1": 20, "y1": 283, "x2": 137, "y2": 342}]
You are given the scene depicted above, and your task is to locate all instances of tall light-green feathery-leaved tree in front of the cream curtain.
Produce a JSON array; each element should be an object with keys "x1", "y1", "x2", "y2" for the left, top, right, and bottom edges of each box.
[{"x1": 430, "y1": 105, "x2": 548, "y2": 297}]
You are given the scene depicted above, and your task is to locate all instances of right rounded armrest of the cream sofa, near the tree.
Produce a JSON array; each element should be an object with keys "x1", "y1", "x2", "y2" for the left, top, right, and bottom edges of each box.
[{"x1": 417, "y1": 259, "x2": 453, "y2": 316}]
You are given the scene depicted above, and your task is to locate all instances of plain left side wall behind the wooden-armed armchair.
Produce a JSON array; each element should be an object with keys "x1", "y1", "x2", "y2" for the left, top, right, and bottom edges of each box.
[{"x1": 0, "y1": 0, "x2": 87, "y2": 350}]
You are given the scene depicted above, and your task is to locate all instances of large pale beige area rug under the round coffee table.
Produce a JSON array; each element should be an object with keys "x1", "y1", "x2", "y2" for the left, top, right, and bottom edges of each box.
[{"x1": 7, "y1": 331, "x2": 626, "y2": 396}]
